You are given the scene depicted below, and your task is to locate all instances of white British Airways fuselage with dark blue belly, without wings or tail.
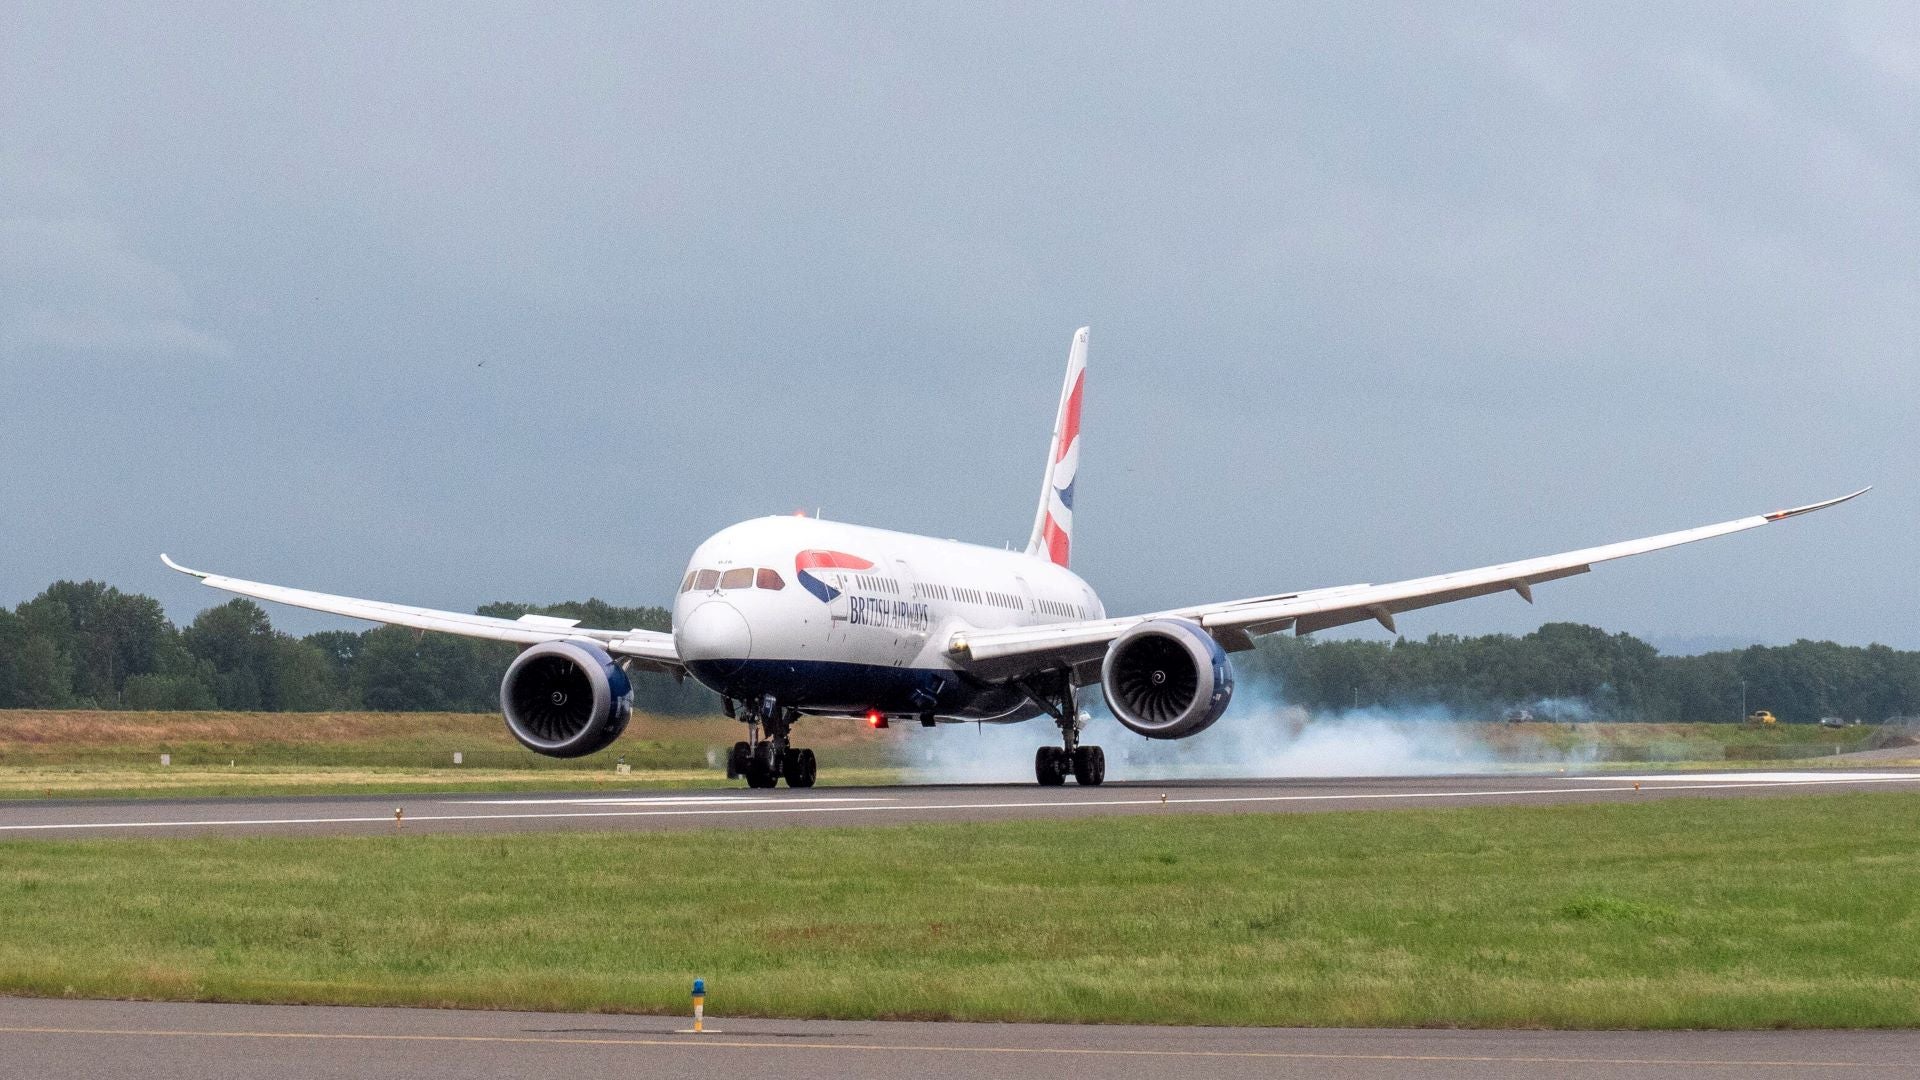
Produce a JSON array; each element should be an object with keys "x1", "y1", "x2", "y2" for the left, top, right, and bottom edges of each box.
[{"x1": 674, "y1": 517, "x2": 1106, "y2": 721}]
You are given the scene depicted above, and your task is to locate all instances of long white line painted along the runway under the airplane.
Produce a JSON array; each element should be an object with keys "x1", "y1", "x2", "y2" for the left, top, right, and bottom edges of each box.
[{"x1": 0, "y1": 773, "x2": 1920, "y2": 832}]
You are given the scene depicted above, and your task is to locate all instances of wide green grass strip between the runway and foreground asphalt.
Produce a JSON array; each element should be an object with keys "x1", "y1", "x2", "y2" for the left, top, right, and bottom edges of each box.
[{"x1": 0, "y1": 792, "x2": 1920, "y2": 1028}]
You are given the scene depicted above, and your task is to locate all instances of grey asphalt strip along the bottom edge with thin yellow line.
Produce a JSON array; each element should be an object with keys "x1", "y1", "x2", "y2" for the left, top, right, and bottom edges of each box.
[{"x1": 0, "y1": 988, "x2": 1920, "y2": 1080}]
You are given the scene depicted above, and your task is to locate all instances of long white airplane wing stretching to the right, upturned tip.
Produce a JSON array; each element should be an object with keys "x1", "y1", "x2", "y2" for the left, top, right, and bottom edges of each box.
[{"x1": 948, "y1": 488, "x2": 1870, "y2": 684}]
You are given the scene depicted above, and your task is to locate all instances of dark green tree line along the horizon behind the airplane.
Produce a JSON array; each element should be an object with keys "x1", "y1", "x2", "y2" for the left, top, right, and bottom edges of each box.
[{"x1": 0, "y1": 580, "x2": 1920, "y2": 723}]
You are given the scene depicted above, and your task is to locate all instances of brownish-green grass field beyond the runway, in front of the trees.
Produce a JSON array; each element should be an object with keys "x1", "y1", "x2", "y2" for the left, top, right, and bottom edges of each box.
[{"x1": 0, "y1": 709, "x2": 1889, "y2": 799}]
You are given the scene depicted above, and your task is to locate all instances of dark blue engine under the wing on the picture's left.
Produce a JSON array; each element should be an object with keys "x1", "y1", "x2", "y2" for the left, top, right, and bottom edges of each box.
[{"x1": 499, "y1": 642, "x2": 634, "y2": 757}]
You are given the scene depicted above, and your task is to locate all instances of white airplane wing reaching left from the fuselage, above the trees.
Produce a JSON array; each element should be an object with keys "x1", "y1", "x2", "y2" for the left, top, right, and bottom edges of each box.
[{"x1": 159, "y1": 555, "x2": 684, "y2": 675}]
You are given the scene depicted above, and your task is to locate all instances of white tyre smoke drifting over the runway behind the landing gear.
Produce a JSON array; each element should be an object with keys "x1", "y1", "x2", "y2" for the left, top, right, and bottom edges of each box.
[{"x1": 899, "y1": 686, "x2": 1500, "y2": 784}]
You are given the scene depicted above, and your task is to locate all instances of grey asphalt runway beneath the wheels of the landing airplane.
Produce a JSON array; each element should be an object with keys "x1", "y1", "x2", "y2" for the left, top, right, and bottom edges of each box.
[{"x1": 0, "y1": 769, "x2": 1920, "y2": 842}]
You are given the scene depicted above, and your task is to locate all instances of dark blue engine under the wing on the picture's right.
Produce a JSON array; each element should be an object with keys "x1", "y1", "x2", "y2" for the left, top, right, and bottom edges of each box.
[{"x1": 1100, "y1": 619, "x2": 1233, "y2": 738}]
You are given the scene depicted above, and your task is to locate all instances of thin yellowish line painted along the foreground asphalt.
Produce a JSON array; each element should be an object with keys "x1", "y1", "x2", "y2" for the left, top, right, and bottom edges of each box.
[{"x1": 0, "y1": 1028, "x2": 1920, "y2": 1068}]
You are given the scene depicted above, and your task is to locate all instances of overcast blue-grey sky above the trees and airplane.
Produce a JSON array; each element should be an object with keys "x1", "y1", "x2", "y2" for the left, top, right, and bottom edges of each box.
[{"x1": 0, "y1": 0, "x2": 1920, "y2": 648}]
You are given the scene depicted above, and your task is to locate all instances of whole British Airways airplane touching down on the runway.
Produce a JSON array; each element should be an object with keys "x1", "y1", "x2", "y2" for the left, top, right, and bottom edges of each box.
[{"x1": 161, "y1": 327, "x2": 1870, "y2": 788}]
